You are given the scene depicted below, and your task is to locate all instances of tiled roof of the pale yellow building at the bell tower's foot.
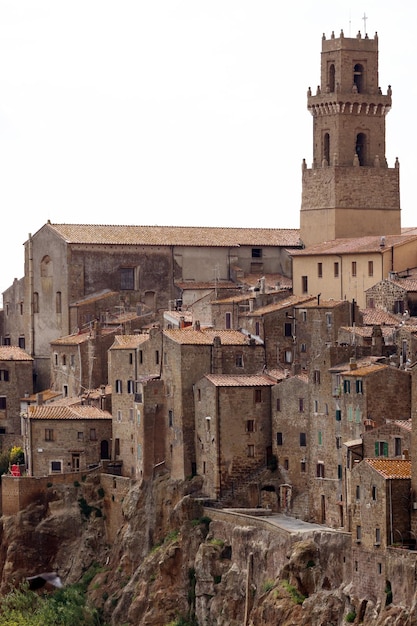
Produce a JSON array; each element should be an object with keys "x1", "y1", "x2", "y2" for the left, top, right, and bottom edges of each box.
[{"x1": 290, "y1": 234, "x2": 417, "y2": 257}]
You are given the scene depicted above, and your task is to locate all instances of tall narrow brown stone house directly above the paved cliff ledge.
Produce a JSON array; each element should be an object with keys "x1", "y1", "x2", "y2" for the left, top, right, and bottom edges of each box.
[{"x1": 194, "y1": 374, "x2": 274, "y2": 506}]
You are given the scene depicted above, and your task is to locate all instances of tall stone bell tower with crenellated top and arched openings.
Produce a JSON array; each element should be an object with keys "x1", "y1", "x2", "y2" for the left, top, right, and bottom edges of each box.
[{"x1": 300, "y1": 31, "x2": 401, "y2": 246}]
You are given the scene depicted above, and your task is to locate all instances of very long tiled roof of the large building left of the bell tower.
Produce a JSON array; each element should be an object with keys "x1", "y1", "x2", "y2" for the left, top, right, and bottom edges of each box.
[{"x1": 48, "y1": 223, "x2": 300, "y2": 247}]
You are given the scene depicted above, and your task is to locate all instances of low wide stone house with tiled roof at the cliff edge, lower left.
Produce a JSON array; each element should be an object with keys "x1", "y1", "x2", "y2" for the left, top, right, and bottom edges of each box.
[{"x1": 23, "y1": 404, "x2": 112, "y2": 476}]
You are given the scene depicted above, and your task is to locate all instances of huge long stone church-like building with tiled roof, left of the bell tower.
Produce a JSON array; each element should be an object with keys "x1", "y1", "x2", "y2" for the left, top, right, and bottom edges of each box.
[{"x1": 3, "y1": 222, "x2": 299, "y2": 390}]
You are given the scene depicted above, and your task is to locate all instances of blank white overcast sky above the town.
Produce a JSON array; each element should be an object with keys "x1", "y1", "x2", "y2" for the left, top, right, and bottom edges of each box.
[{"x1": 0, "y1": 0, "x2": 417, "y2": 292}]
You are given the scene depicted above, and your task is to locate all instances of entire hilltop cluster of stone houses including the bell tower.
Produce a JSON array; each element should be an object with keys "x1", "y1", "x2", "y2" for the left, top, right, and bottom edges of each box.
[{"x1": 0, "y1": 28, "x2": 417, "y2": 595}]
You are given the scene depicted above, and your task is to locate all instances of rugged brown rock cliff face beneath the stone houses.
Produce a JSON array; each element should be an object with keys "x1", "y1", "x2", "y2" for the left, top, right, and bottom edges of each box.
[{"x1": 0, "y1": 476, "x2": 417, "y2": 626}]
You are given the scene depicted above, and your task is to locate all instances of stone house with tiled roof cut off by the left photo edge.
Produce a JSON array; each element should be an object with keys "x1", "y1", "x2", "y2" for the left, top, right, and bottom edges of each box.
[{"x1": 0, "y1": 346, "x2": 33, "y2": 450}]
